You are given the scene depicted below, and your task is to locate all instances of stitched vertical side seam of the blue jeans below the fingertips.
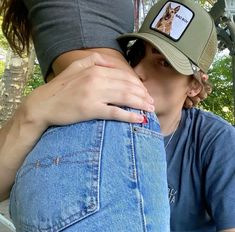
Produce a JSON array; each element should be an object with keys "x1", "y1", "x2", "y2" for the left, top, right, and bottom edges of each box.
[{"x1": 130, "y1": 124, "x2": 147, "y2": 232}]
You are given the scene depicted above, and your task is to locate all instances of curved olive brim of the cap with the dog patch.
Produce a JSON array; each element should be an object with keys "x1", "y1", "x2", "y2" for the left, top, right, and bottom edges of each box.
[{"x1": 117, "y1": 33, "x2": 194, "y2": 75}]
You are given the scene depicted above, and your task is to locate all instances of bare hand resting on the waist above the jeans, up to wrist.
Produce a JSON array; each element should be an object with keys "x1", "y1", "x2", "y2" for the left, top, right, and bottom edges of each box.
[{"x1": 24, "y1": 54, "x2": 154, "y2": 128}]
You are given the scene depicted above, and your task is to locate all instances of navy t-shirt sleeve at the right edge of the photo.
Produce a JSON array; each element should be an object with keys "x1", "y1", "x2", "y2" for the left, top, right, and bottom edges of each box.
[{"x1": 203, "y1": 125, "x2": 235, "y2": 231}]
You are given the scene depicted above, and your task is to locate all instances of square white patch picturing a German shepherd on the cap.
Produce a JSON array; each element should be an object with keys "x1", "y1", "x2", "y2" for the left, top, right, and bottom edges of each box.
[{"x1": 151, "y1": 1, "x2": 194, "y2": 41}]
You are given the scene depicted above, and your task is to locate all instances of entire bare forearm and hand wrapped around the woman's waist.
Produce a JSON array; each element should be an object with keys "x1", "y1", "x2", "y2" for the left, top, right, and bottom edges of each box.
[{"x1": 0, "y1": 54, "x2": 154, "y2": 200}]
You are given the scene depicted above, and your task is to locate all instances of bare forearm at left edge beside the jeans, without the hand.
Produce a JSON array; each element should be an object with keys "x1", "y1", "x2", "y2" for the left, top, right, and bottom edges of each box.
[{"x1": 0, "y1": 106, "x2": 46, "y2": 201}]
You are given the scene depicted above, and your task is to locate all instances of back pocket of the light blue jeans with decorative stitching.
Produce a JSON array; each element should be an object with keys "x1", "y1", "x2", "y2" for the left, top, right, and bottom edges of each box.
[{"x1": 10, "y1": 120, "x2": 103, "y2": 232}]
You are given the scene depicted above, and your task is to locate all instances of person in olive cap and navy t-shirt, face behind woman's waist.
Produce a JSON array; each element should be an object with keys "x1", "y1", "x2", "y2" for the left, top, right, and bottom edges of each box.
[{"x1": 118, "y1": 0, "x2": 235, "y2": 232}]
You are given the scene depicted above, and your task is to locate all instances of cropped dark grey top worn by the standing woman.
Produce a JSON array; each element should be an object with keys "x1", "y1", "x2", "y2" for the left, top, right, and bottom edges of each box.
[{"x1": 24, "y1": 0, "x2": 134, "y2": 77}]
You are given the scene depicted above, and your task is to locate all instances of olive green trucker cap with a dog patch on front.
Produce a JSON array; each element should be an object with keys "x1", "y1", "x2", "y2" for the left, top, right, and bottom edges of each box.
[{"x1": 118, "y1": 0, "x2": 217, "y2": 75}]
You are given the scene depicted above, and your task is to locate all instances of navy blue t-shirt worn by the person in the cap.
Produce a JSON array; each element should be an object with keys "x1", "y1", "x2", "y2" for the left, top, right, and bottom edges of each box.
[{"x1": 165, "y1": 109, "x2": 235, "y2": 232}]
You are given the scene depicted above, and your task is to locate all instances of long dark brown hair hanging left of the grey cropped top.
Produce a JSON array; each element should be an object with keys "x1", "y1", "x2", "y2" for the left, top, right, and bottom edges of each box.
[{"x1": 0, "y1": 0, "x2": 31, "y2": 56}]
